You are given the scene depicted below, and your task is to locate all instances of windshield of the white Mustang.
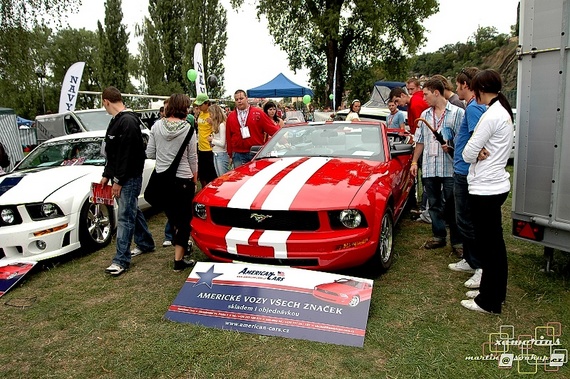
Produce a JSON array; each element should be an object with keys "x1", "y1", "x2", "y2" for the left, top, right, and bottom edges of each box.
[{"x1": 15, "y1": 137, "x2": 105, "y2": 171}]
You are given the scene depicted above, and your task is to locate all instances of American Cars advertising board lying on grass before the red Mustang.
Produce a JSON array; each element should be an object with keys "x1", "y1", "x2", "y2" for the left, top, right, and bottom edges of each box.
[{"x1": 165, "y1": 262, "x2": 373, "y2": 347}]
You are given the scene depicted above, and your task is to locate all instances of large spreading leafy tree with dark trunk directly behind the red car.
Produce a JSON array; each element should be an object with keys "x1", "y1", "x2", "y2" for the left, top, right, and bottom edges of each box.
[{"x1": 231, "y1": 0, "x2": 438, "y2": 104}]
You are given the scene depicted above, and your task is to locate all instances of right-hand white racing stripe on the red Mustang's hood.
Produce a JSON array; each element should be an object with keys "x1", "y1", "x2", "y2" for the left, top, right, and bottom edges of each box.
[{"x1": 261, "y1": 157, "x2": 330, "y2": 210}]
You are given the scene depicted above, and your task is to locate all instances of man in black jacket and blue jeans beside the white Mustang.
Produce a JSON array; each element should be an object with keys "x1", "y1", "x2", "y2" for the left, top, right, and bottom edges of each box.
[{"x1": 101, "y1": 87, "x2": 154, "y2": 276}]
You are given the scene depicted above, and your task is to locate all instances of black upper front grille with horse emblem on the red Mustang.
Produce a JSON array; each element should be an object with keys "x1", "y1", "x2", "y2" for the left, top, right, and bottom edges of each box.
[{"x1": 210, "y1": 207, "x2": 320, "y2": 231}]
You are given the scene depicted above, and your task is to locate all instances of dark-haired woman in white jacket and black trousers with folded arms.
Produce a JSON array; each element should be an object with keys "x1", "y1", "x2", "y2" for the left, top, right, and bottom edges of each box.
[{"x1": 461, "y1": 70, "x2": 513, "y2": 313}]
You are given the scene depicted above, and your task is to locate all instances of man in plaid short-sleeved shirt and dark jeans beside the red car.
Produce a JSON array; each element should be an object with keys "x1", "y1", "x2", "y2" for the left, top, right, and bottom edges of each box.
[{"x1": 410, "y1": 79, "x2": 464, "y2": 249}]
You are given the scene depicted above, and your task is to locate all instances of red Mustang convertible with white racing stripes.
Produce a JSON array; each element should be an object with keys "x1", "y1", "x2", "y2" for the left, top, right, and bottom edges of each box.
[{"x1": 192, "y1": 121, "x2": 414, "y2": 271}]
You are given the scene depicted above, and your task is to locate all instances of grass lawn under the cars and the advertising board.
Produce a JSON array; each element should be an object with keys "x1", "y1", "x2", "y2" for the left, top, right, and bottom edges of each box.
[{"x1": 0, "y1": 180, "x2": 570, "y2": 379}]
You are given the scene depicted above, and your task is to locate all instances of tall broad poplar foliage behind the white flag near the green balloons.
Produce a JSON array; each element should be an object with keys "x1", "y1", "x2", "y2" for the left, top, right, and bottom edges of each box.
[{"x1": 137, "y1": 0, "x2": 227, "y2": 97}]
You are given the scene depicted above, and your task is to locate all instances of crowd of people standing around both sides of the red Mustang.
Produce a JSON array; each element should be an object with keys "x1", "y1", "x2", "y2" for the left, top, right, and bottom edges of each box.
[{"x1": 97, "y1": 67, "x2": 513, "y2": 313}]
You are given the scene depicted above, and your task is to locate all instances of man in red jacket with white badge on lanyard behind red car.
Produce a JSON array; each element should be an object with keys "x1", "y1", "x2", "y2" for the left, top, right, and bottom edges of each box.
[{"x1": 226, "y1": 90, "x2": 279, "y2": 168}]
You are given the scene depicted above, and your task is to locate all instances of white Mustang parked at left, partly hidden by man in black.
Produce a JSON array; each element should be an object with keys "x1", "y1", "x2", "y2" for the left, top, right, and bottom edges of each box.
[{"x1": 0, "y1": 131, "x2": 154, "y2": 262}]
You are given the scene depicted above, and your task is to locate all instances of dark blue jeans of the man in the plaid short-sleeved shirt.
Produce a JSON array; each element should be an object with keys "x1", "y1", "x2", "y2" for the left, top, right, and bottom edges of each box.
[{"x1": 423, "y1": 176, "x2": 461, "y2": 246}]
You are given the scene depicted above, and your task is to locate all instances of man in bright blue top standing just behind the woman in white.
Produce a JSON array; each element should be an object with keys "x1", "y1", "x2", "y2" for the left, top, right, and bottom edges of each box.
[{"x1": 449, "y1": 67, "x2": 487, "y2": 288}]
